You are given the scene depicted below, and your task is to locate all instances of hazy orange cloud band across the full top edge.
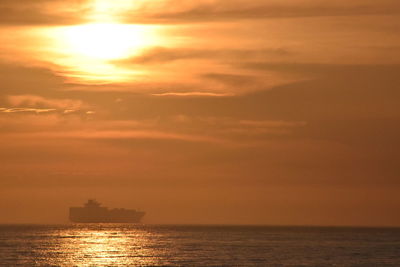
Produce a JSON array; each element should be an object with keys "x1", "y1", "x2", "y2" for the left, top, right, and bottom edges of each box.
[{"x1": 0, "y1": 0, "x2": 400, "y2": 25}]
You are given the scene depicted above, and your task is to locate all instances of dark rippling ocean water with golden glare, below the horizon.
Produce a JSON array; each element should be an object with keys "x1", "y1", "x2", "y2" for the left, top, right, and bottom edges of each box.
[{"x1": 0, "y1": 224, "x2": 400, "y2": 267}]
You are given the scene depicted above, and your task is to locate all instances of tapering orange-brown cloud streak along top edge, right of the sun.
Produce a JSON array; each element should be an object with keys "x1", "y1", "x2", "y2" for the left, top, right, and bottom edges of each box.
[{"x1": 127, "y1": 0, "x2": 400, "y2": 23}]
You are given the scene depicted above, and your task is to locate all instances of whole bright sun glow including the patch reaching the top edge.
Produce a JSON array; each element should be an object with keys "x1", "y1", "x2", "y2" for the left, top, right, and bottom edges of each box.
[{"x1": 16, "y1": 0, "x2": 168, "y2": 83}]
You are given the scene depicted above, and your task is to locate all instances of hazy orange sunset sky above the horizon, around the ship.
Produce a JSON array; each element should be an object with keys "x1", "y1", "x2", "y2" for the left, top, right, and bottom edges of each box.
[{"x1": 0, "y1": 0, "x2": 400, "y2": 226}]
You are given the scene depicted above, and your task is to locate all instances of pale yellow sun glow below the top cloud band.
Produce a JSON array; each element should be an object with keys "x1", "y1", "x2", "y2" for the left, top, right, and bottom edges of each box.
[{"x1": 38, "y1": 23, "x2": 165, "y2": 83}]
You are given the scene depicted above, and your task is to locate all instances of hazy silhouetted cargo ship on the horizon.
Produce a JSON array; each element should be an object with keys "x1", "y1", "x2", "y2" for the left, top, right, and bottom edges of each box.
[{"x1": 69, "y1": 199, "x2": 145, "y2": 223}]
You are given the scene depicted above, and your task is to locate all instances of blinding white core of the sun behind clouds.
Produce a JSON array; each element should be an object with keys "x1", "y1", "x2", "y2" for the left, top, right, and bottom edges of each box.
[{"x1": 64, "y1": 23, "x2": 149, "y2": 60}]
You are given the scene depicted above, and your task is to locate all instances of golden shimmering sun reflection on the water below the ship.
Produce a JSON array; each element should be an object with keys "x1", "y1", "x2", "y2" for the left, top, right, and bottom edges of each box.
[{"x1": 51, "y1": 226, "x2": 162, "y2": 266}]
